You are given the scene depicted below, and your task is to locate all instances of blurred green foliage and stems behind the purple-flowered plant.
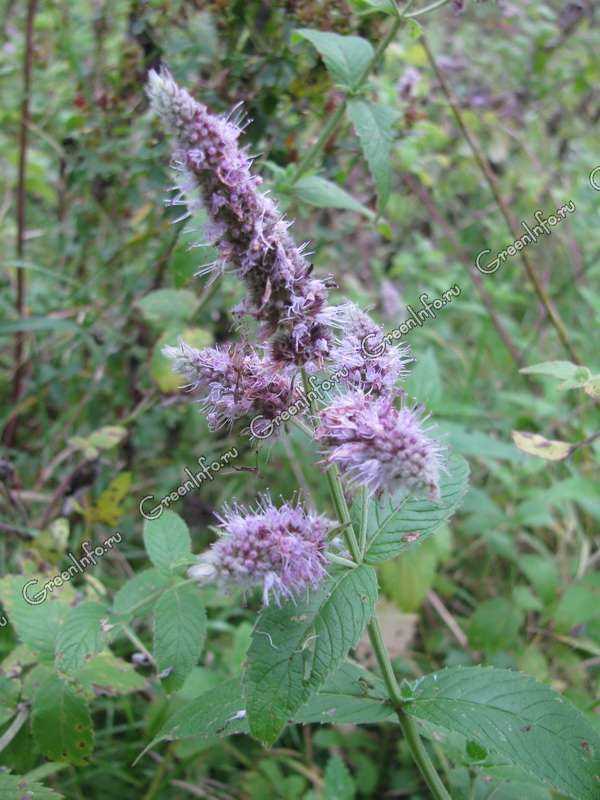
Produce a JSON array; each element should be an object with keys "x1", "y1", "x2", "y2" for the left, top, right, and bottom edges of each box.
[{"x1": 0, "y1": 0, "x2": 600, "y2": 800}]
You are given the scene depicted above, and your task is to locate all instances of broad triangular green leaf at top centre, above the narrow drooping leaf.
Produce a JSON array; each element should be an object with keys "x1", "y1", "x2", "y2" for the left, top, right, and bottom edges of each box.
[{"x1": 294, "y1": 28, "x2": 373, "y2": 89}]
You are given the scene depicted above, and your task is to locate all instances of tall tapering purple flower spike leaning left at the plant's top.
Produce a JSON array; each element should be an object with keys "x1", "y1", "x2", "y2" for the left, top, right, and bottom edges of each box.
[{"x1": 148, "y1": 70, "x2": 330, "y2": 365}]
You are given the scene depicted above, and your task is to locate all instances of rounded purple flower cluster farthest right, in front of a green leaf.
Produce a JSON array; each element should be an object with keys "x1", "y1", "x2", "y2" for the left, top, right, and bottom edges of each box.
[{"x1": 315, "y1": 391, "x2": 443, "y2": 500}]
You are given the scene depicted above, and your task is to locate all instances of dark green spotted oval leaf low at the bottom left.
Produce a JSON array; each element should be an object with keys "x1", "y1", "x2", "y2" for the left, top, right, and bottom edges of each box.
[{"x1": 31, "y1": 675, "x2": 94, "y2": 765}]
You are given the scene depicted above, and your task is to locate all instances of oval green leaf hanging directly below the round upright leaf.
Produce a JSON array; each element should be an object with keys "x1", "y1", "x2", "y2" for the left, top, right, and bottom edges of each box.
[{"x1": 154, "y1": 583, "x2": 206, "y2": 692}]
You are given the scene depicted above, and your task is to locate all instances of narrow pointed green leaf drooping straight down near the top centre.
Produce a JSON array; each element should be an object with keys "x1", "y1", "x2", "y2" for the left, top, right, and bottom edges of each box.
[{"x1": 348, "y1": 99, "x2": 397, "y2": 211}]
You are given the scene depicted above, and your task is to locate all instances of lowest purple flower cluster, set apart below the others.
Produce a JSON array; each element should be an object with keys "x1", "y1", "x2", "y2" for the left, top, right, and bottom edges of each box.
[{"x1": 188, "y1": 496, "x2": 335, "y2": 605}]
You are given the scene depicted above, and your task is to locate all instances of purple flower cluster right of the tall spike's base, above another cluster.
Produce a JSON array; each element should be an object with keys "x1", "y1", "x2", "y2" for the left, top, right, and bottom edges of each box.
[{"x1": 330, "y1": 303, "x2": 412, "y2": 394}]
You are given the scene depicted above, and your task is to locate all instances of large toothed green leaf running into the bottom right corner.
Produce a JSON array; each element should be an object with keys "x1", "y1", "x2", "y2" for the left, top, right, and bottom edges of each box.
[{"x1": 405, "y1": 667, "x2": 600, "y2": 800}]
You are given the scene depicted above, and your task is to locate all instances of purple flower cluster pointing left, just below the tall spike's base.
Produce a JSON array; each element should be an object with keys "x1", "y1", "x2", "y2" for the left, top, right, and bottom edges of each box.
[{"x1": 163, "y1": 341, "x2": 300, "y2": 430}]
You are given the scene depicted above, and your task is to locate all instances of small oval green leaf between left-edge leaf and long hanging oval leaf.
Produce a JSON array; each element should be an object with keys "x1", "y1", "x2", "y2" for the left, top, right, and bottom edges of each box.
[{"x1": 56, "y1": 603, "x2": 108, "y2": 672}]
